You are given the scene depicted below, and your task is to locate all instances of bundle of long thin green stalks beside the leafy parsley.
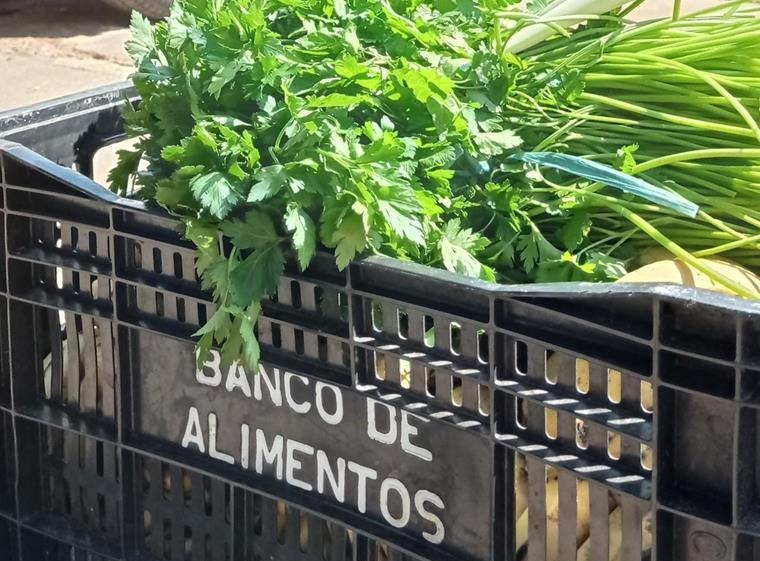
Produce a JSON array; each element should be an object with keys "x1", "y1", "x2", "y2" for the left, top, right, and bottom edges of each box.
[{"x1": 509, "y1": 2, "x2": 760, "y2": 298}]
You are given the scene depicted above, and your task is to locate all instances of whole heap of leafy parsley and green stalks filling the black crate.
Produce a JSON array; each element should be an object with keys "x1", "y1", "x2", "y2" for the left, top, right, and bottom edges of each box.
[{"x1": 112, "y1": 0, "x2": 760, "y2": 365}]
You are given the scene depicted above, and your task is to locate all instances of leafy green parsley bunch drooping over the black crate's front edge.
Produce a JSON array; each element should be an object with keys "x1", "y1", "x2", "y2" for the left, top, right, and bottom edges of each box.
[{"x1": 116, "y1": 0, "x2": 644, "y2": 366}]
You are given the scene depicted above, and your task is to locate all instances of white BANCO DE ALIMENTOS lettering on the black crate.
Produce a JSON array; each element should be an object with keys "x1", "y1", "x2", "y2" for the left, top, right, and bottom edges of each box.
[{"x1": 182, "y1": 351, "x2": 446, "y2": 544}]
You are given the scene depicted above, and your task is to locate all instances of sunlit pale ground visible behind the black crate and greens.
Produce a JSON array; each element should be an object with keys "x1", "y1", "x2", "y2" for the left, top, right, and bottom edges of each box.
[{"x1": 0, "y1": 0, "x2": 717, "y2": 111}]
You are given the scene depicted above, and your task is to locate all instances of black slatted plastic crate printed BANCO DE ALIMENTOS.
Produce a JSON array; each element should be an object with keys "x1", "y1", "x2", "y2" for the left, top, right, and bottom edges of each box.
[{"x1": 0, "y1": 83, "x2": 760, "y2": 561}]
